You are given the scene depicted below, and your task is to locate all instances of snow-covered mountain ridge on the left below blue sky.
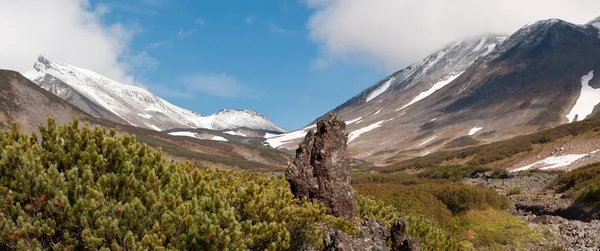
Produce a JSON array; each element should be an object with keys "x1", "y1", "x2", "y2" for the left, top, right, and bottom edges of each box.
[{"x1": 25, "y1": 56, "x2": 284, "y2": 132}]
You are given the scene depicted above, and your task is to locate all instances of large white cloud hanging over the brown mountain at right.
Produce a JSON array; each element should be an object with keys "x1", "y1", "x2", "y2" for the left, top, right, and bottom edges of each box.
[{"x1": 304, "y1": 0, "x2": 600, "y2": 70}]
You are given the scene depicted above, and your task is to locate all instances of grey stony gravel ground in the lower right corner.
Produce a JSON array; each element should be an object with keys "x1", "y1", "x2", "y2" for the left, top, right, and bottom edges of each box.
[{"x1": 463, "y1": 172, "x2": 600, "y2": 250}]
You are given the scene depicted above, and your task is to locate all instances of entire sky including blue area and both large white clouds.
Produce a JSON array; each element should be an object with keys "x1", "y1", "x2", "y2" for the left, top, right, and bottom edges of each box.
[{"x1": 0, "y1": 0, "x2": 600, "y2": 129}]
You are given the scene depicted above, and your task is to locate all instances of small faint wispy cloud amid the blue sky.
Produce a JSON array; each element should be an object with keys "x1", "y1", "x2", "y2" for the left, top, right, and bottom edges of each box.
[{"x1": 183, "y1": 73, "x2": 243, "y2": 98}]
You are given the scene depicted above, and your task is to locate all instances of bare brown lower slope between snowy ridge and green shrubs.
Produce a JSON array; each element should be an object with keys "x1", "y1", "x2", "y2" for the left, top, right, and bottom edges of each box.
[{"x1": 0, "y1": 70, "x2": 291, "y2": 172}]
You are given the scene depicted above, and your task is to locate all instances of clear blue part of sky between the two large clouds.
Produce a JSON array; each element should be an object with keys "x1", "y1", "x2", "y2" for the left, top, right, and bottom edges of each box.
[{"x1": 91, "y1": 0, "x2": 389, "y2": 129}]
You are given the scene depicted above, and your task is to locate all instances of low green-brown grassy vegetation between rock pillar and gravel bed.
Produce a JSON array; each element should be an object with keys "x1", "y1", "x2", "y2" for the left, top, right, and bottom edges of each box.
[{"x1": 352, "y1": 170, "x2": 543, "y2": 250}]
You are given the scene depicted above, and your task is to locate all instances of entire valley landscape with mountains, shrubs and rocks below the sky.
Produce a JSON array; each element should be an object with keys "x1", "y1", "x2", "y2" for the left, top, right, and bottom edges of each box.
[{"x1": 0, "y1": 5, "x2": 600, "y2": 251}]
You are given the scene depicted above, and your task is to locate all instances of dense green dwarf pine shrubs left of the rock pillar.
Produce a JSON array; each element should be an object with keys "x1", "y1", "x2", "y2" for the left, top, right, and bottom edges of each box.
[{"x1": 0, "y1": 119, "x2": 340, "y2": 250}]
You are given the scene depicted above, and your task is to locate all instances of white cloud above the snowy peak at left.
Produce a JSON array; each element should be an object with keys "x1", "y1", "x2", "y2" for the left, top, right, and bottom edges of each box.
[{"x1": 0, "y1": 0, "x2": 150, "y2": 84}]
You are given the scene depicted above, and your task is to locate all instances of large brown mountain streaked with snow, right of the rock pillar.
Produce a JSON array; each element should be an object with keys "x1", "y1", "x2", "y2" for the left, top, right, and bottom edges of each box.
[{"x1": 267, "y1": 16, "x2": 600, "y2": 164}]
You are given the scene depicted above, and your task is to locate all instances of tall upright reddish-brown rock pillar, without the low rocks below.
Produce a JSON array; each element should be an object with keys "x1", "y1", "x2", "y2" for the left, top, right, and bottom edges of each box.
[{"x1": 285, "y1": 114, "x2": 356, "y2": 220}]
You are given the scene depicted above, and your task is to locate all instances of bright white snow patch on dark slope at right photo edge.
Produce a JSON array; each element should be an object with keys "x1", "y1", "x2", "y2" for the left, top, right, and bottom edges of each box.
[{"x1": 567, "y1": 71, "x2": 600, "y2": 122}]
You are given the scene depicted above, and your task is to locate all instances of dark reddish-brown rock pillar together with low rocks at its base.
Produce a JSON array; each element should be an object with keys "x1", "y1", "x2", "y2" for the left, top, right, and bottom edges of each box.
[{"x1": 285, "y1": 114, "x2": 419, "y2": 251}]
